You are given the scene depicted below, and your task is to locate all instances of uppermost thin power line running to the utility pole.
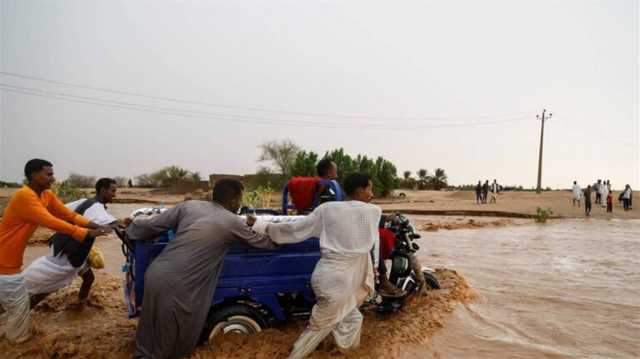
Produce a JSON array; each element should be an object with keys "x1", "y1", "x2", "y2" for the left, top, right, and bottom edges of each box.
[{"x1": 0, "y1": 71, "x2": 532, "y2": 121}]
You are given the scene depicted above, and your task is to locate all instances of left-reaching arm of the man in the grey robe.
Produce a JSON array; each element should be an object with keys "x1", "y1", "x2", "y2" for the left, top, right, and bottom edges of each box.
[{"x1": 127, "y1": 203, "x2": 184, "y2": 240}]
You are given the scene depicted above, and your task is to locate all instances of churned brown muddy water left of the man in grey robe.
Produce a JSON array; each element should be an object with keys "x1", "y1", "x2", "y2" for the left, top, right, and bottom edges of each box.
[{"x1": 0, "y1": 273, "x2": 136, "y2": 358}]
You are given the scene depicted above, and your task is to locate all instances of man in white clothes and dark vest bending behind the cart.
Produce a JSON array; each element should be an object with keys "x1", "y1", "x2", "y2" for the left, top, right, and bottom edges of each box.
[{"x1": 22, "y1": 178, "x2": 117, "y2": 307}]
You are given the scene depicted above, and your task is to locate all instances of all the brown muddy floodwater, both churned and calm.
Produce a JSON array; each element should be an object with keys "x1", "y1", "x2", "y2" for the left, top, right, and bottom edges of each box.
[{"x1": 6, "y1": 215, "x2": 640, "y2": 359}]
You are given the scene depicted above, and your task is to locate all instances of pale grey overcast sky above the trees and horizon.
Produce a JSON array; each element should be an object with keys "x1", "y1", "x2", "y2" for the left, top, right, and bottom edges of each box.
[{"x1": 0, "y1": 0, "x2": 640, "y2": 188}]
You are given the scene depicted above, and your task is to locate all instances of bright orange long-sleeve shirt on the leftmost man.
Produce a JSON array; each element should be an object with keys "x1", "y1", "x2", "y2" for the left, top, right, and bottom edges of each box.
[{"x1": 0, "y1": 186, "x2": 89, "y2": 274}]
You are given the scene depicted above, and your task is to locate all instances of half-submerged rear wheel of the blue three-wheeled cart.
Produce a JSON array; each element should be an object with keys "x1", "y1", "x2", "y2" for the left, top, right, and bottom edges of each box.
[{"x1": 200, "y1": 304, "x2": 267, "y2": 344}]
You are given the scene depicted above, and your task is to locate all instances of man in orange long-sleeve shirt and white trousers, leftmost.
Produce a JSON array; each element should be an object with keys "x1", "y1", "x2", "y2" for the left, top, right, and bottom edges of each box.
[{"x1": 0, "y1": 159, "x2": 111, "y2": 343}]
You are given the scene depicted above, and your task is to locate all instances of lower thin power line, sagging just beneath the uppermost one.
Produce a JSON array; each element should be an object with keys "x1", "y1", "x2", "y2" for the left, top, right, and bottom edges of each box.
[{"x1": 0, "y1": 83, "x2": 529, "y2": 131}]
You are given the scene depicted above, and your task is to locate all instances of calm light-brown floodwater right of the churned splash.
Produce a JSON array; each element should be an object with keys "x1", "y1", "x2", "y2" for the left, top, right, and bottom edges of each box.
[{"x1": 416, "y1": 220, "x2": 640, "y2": 358}]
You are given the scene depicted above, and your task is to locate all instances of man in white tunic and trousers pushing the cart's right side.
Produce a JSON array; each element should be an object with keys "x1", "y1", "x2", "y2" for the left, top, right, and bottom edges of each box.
[{"x1": 250, "y1": 174, "x2": 382, "y2": 359}]
